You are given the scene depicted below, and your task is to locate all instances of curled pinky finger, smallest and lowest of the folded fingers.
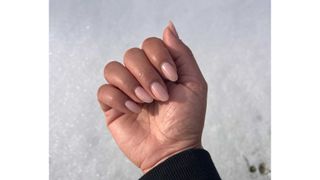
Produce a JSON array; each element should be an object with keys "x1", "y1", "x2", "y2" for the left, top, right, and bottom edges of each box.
[{"x1": 98, "y1": 84, "x2": 141, "y2": 113}]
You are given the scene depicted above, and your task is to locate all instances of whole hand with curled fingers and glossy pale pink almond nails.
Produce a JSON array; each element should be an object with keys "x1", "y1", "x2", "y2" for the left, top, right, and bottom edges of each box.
[{"x1": 98, "y1": 22, "x2": 207, "y2": 172}]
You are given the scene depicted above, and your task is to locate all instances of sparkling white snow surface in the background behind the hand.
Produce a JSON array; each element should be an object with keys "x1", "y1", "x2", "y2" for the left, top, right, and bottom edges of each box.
[{"x1": 50, "y1": 0, "x2": 270, "y2": 180}]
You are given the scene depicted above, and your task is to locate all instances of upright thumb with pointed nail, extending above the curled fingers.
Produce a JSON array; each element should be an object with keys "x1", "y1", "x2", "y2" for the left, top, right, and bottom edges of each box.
[{"x1": 163, "y1": 21, "x2": 205, "y2": 84}]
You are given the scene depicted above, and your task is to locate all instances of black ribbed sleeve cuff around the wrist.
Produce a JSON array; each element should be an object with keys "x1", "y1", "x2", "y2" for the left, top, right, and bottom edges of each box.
[{"x1": 140, "y1": 149, "x2": 221, "y2": 180}]
